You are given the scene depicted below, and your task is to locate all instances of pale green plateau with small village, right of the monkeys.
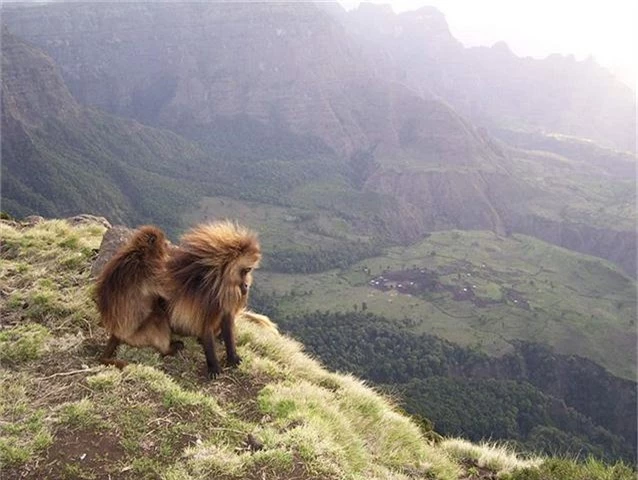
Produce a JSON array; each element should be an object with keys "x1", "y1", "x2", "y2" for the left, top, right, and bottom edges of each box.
[{"x1": 258, "y1": 231, "x2": 636, "y2": 379}]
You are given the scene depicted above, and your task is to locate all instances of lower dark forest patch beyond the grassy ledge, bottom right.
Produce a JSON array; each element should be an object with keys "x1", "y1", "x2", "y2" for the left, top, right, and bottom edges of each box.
[{"x1": 402, "y1": 376, "x2": 635, "y2": 461}]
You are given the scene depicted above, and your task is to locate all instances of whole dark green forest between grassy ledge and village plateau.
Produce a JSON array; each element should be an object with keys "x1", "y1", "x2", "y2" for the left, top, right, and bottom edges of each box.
[{"x1": 252, "y1": 308, "x2": 636, "y2": 462}]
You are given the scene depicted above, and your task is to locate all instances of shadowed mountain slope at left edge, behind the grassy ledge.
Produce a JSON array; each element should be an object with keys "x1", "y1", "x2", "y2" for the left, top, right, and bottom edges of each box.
[{"x1": 2, "y1": 28, "x2": 215, "y2": 229}]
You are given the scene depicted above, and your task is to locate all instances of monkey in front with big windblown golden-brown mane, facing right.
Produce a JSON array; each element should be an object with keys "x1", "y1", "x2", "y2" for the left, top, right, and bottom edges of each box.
[{"x1": 166, "y1": 222, "x2": 261, "y2": 378}]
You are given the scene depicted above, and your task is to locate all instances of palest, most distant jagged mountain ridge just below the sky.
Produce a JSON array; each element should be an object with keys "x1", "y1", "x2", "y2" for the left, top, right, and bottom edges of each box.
[{"x1": 336, "y1": 3, "x2": 636, "y2": 152}]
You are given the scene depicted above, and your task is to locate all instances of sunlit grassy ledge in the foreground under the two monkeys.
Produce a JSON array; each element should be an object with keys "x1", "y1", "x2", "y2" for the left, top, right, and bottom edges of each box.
[{"x1": 0, "y1": 221, "x2": 634, "y2": 480}]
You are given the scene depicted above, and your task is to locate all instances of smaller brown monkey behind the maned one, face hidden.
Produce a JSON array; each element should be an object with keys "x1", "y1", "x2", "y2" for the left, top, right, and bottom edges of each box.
[{"x1": 95, "y1": 225, "x2": 181, "y2": 367}]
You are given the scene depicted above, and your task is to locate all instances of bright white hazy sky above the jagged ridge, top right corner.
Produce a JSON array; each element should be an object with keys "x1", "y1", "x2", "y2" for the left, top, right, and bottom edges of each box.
[{"x1": 340, "y1": 0, "x2": 638, "y2": 85}]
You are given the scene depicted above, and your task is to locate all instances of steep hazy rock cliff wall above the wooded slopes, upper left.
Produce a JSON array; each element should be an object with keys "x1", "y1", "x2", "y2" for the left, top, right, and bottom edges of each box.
[{"x1": 1, "y1": 3, "x2": 500, "y2": 161}]
